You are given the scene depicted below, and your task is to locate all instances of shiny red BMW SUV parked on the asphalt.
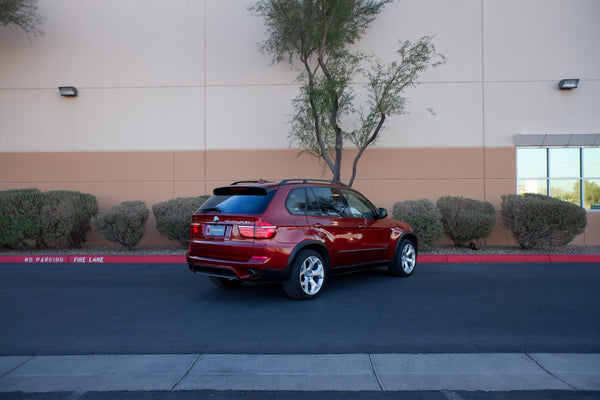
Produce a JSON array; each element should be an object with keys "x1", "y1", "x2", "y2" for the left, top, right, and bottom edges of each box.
[{"x1": 187, "y1": 179, "x2": 418, "y2": 299}]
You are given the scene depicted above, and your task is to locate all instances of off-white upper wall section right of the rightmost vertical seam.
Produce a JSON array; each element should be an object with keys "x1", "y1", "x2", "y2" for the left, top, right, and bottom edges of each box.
[{"x1": 483, "y1": 0, "x2": 600, "y2": 146}]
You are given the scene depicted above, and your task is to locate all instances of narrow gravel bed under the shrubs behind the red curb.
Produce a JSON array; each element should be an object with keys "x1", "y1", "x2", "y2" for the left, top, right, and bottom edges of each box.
[{"x1": 0, "y1": 244, "x2": 600, "y2": 256}]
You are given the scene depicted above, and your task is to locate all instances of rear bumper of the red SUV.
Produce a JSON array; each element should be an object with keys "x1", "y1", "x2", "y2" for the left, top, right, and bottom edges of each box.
[{"x1": 186, "y1": 254, "x2": 287, "y2": 281}]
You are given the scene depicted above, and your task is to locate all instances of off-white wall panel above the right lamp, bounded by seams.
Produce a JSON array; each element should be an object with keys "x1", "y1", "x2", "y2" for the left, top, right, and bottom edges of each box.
[{"x1": 483, "y1": 0, "x2": 600, "y2": 82}]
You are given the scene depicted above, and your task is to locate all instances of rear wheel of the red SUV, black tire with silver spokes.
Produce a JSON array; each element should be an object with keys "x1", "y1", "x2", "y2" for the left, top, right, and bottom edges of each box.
[{"x1": 282, "y1": 250, "x2": 327, "y2": 300}]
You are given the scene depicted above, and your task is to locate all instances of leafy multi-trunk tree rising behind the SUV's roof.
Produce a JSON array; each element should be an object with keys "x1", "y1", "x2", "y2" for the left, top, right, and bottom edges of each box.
[{"x1": 250, "y1": 0, "x2": 445, "y2": 185}]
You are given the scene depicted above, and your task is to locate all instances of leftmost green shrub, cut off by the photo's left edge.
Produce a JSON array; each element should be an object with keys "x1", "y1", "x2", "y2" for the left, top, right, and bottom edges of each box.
[{"x1": 0, "y1": 189, "x2": 42, "y2": 248}]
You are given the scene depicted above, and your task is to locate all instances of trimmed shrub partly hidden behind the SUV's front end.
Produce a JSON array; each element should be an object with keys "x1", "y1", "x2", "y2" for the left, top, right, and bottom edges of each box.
[{"x1": 392, "y1": 199, "x2": 444, "y2": 251}]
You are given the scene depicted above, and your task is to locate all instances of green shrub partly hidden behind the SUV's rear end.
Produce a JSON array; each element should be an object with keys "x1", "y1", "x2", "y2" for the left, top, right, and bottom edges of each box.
[{"x1": 152, "y1": 196, "x2": 209, "y2": 246}]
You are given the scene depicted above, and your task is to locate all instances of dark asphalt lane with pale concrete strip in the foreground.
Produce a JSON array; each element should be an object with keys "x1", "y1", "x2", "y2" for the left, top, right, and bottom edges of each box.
[{"x1": 0, "y1": 263, "x2": 600, "y2": 399}]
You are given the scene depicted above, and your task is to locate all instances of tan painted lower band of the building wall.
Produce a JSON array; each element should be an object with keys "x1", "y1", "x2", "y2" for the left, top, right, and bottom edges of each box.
[{"x1": 0, "y1": 148, "x2": 600, "y2": 245}]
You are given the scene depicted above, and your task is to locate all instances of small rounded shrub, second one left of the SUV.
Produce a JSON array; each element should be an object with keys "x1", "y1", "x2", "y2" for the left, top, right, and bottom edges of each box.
[{"x1": 92, "y1": 201, "x2": 150, "y2": 250}]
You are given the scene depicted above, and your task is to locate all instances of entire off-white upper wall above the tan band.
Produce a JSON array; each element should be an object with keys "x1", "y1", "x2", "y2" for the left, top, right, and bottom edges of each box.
[{"x1": 0, "y1": 0, "x2": 600, "y2": 151}]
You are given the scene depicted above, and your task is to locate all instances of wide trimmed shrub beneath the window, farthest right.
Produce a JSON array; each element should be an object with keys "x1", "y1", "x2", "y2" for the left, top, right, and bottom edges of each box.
[{"x1": 502, "y1": 193, "x2": 587, "y2": 249}]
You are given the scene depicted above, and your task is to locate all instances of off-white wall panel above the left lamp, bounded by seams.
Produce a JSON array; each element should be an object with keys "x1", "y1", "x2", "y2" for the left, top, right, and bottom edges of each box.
[{"x1": 0, "y1": 0, "x2": 205, "y2": 89}]
